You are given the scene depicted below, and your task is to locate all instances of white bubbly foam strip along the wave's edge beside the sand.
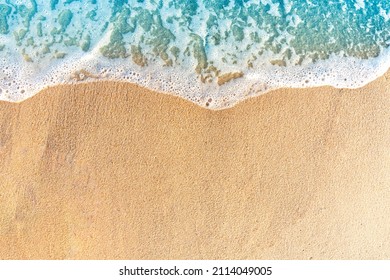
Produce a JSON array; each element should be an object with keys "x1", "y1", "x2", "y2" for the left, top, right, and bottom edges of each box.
[{"x1": 0, "y1": 42, "x2": 390, "y2": 109}]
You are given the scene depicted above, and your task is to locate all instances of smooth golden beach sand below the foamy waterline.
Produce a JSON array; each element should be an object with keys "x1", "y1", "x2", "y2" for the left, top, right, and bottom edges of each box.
[{"x1": 0, "y1": 73, "x2": 390, "y2": 259}]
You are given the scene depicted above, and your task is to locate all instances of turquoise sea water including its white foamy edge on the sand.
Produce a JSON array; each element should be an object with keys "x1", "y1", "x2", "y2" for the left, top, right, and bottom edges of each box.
[{"x1": 0, "y1": 0, "x2": 390, "y2": 108}]
